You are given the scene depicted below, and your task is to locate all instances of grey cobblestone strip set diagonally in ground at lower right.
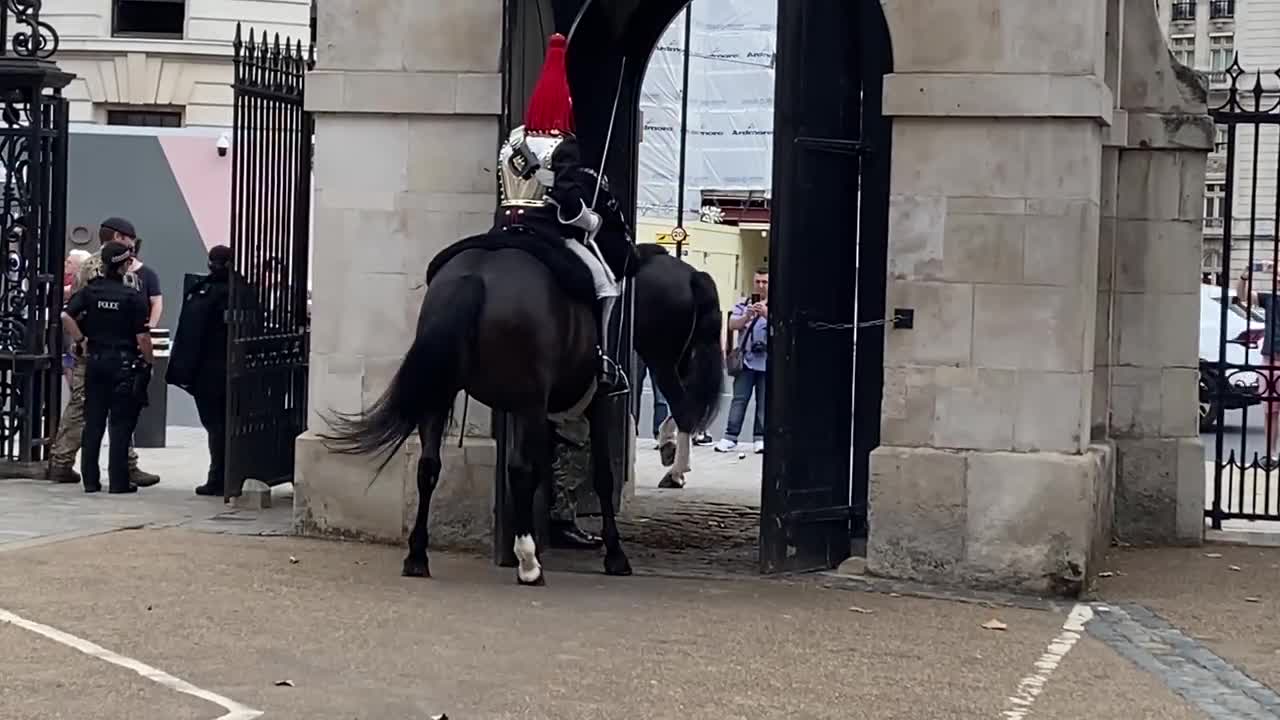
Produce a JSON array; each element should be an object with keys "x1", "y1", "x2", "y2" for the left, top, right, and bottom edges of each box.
[{"x1": 1087, "y1": 603, "x2": 1280, "y2": 720}]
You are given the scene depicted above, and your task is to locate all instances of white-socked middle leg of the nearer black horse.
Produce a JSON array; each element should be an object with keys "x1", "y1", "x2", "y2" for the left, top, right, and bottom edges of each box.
[{"x1": 507, "y1": 413, "x2": 550, "y2": 585}]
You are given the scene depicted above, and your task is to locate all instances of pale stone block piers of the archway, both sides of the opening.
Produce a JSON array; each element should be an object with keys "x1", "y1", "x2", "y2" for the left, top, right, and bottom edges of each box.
[{"x1": 297, "y1": 0, "x2": 1212, "y2": 593}]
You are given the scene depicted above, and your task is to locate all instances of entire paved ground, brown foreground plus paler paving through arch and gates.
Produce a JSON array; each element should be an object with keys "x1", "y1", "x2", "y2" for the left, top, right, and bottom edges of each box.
[{"x1": 0, "y1": 429, "x2": 1280, "y2": 720}]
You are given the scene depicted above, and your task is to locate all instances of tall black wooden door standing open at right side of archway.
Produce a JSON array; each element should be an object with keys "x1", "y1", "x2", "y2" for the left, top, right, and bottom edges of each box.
[{"x1": 760, "y1": 0, "x2": 888, "y2": 573}]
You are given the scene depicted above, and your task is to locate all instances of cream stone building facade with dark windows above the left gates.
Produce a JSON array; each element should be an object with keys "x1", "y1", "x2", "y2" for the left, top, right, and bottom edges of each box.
[{"x1": 42, "y1": 0, "x2": 312, "y2": 128}]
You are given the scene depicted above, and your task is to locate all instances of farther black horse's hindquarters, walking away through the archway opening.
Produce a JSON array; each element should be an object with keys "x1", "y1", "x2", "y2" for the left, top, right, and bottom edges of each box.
[{"x1": 634, "y1": 245, "x2": 724, "y2": 488}]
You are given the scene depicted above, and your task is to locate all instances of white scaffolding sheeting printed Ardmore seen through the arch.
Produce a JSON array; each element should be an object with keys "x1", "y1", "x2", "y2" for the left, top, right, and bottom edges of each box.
[{"x1": 637, "y1": 0, "x2": 778, "y2": 222}]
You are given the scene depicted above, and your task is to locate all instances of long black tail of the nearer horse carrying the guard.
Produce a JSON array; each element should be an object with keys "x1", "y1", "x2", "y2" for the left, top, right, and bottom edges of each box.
[{"x1": 320, "y1": 275, "x2": 485, "y2": 473}]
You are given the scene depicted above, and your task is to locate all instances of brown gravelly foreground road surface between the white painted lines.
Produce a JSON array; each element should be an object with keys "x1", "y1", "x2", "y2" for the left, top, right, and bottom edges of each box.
[{"x1": 0, "y1": 527, "x2": 1203, "y2": 720}]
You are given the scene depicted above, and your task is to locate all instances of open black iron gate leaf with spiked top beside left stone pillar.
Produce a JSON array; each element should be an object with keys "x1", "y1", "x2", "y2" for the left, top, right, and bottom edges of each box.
[{"x1": 225, "y1": 26, "x2": 315, "y2": 497}]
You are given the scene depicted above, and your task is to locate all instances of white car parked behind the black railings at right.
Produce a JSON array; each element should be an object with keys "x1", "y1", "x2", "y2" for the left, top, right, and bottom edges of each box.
[{"x1": 1199, "y1": 284, "x2": 1266, "y2": 432}]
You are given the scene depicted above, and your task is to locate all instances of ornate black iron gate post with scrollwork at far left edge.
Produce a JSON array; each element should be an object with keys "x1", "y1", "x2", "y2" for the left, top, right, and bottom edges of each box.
[{"x1": 0, "y1": 1, "x2": 74, "y2": 475}]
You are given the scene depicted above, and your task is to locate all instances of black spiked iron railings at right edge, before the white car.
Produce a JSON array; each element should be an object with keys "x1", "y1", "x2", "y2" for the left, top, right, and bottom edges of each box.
[{"x1": 1199, "y1": 63, "x2": 1280, "y2": 529}]
